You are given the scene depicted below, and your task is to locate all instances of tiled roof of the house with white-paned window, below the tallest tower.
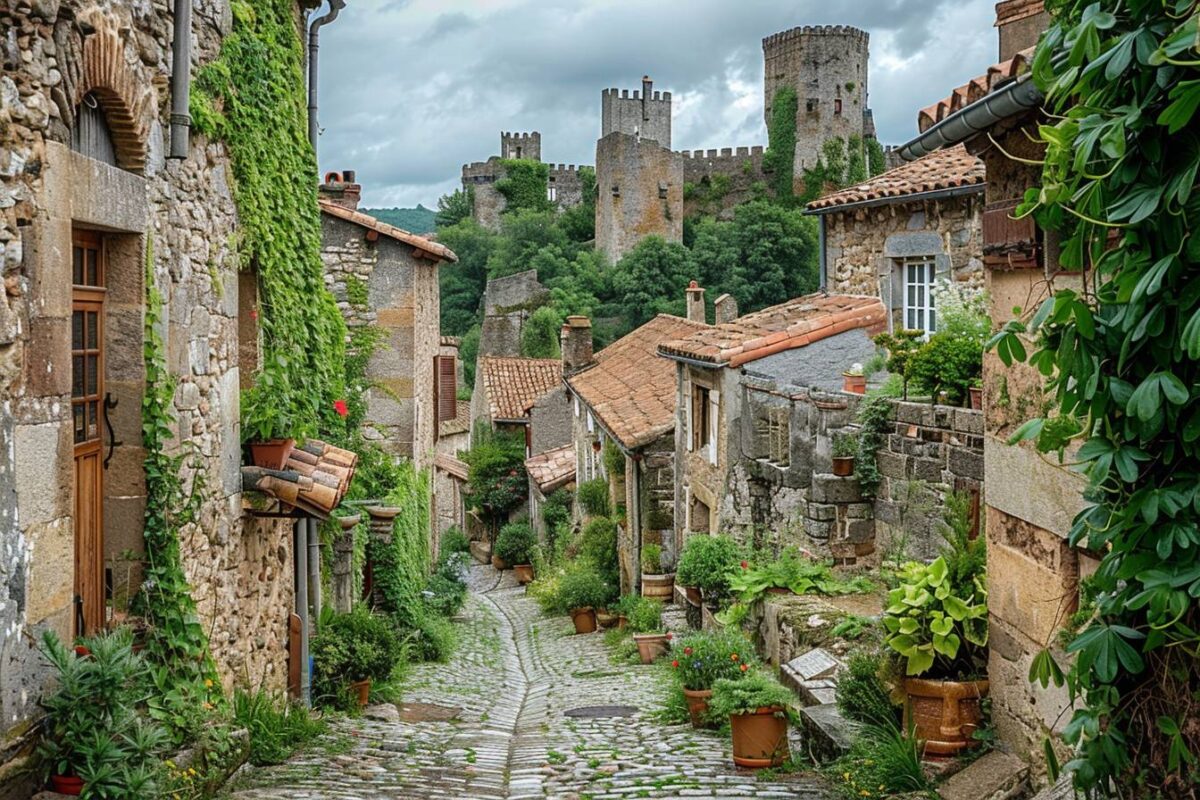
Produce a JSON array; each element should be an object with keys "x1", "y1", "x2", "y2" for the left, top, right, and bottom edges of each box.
[{"x1": 808, "y1": 144, "x2": 985, "y2": 211}]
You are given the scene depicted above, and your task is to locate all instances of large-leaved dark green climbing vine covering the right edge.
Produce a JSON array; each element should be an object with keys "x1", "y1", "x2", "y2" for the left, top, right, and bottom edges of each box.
[{"x1": 990, "y1": 0, "x2": 1200, "y2": 798}]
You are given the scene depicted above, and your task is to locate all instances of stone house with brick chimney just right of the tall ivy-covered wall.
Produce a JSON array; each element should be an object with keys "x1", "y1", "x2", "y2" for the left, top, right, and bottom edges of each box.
[{"x1": 319, "y1": 172, "x2": 458, "y2": 468}]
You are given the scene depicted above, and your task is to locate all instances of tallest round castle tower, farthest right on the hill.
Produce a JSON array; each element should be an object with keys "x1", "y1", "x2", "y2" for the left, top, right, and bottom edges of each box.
[{"x1": 762, "y1": 25, "x2": 875, "y2": 178}]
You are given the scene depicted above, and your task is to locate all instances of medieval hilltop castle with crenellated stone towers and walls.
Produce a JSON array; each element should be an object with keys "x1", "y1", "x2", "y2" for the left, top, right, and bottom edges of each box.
[{"x1": 462, "y1": 25, "x2": 875, "y2": 263}]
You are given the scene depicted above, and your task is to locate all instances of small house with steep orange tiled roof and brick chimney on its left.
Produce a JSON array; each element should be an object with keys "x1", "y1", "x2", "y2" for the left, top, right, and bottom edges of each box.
[{"x1": 563, "y1": 309, "x2": 708, "y2": 591}]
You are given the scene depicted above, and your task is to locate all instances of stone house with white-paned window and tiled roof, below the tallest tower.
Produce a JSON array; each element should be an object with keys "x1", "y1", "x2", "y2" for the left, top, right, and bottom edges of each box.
[{"x1": 806, "y1": 146, "x2": 984, "y2": 332}]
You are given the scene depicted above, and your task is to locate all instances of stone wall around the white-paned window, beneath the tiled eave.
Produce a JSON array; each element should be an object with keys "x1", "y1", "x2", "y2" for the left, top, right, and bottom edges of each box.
[{"x1": 822, "y1": 193, "x2": 983, "y2": 326}]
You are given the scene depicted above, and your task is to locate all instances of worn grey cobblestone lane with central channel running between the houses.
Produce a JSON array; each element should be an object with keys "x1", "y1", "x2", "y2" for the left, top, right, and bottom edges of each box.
[{"x1": 229, "y1": 567, "x2": 832, "y2": 800}]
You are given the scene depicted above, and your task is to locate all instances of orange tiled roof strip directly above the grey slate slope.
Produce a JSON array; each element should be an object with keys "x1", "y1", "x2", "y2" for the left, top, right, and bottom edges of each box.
[{"x1": 659, "y1": 294, "x2": 887, "y2": 367}]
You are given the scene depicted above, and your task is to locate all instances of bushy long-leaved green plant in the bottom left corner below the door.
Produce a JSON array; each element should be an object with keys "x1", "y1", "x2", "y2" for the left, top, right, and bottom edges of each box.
[{"x1": 38, "y1": 628, "x2": 169, "y2": 798}]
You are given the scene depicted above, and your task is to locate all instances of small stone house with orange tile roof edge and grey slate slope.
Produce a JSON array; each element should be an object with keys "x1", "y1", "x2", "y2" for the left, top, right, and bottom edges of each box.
[{"x1": 658, "y1": 294, "x2": 886, "y2": 561}]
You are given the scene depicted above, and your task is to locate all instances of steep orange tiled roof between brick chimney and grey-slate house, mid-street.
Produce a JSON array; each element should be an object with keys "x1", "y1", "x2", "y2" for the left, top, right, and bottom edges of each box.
[{"x1": 566, "y1": 314, "x2": 709, "y2": 450}]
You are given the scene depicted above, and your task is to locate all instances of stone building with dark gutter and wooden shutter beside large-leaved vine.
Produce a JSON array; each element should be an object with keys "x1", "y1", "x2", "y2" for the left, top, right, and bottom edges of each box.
[{"x1": 901, "y1": 0, "x2": 1097, "y2": 768}]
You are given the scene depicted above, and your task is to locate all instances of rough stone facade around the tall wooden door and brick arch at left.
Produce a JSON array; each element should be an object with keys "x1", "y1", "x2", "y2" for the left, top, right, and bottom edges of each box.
[{"x1": 0, "y1": 0, "x2": 300, "y2": 794}]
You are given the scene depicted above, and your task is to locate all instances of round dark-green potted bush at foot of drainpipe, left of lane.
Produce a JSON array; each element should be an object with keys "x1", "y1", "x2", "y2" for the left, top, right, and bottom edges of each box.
[{"x1": 312, "y1": 606, "x2": 404, "y2": 710}]
